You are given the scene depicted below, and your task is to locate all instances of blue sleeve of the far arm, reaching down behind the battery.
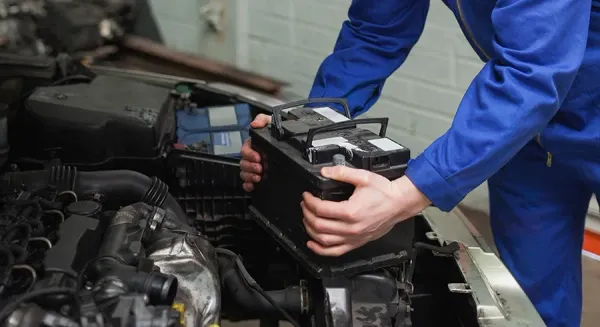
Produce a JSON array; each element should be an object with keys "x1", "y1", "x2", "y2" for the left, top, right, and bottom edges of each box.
[{"x1": 309, "y1": 0, "x2": 429, "y2": 116}]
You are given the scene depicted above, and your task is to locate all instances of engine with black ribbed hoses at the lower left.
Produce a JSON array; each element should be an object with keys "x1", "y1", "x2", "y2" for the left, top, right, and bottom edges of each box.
[{"x1": 0, "y1": 166, "x2": 211, "y2": 327}]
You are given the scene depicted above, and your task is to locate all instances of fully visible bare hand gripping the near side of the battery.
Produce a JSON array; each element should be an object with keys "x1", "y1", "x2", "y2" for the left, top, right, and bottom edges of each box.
[{"x1": 301, "y1": 166, "x2": 431, "y2": 256}]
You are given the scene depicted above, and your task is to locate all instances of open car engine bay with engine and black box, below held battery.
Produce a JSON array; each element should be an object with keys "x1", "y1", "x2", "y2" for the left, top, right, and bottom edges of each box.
[{"x1": 0, "y1": 62, "x2": 488, "y2": 327}]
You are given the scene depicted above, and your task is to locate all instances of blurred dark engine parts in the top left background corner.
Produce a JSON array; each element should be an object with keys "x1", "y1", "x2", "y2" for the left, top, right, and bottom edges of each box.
[{"x1": 0, "y1": 0, "x2": 137, "y2": 56}]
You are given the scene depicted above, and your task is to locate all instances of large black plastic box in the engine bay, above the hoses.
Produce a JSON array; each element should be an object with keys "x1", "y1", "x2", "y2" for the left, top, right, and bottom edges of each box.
[{"x1": 22, "y1": 76, "x2": 175, "y2": 164}]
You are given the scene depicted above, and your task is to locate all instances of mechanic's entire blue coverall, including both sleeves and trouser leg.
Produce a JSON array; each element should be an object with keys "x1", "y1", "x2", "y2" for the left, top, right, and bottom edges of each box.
[{"x1": 310, "y1": 0, "x2": 600, "y2": 327}]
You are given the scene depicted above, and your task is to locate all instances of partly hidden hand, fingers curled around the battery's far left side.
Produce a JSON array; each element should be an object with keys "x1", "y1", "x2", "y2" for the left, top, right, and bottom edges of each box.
[{"x1": 240, "y1": 114, "x2": 271, "y2": 192}]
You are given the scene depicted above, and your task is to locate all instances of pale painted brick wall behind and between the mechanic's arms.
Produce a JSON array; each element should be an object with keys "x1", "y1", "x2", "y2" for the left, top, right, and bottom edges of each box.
[{"x1": 238, "y1": 0, "x2": 487, "y2": 210}]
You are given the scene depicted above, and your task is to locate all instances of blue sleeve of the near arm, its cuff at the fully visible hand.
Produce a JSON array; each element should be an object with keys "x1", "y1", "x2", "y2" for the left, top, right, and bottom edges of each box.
[{"x1": 406, "y1": 0, "x2": 592, "y2": 211}]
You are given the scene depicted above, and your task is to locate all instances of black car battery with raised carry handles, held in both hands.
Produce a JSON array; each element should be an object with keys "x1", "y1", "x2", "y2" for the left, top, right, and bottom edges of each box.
[{"x1": 250, "y1": 98, "x2": 414, "y2": 278}]
